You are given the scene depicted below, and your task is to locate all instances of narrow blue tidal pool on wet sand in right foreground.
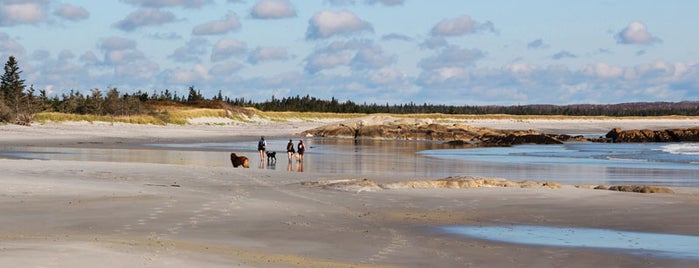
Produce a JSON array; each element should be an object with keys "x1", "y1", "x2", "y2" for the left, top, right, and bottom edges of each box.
[{"x1": 440, "y1": 225, "x2": 699, "y2": 259}]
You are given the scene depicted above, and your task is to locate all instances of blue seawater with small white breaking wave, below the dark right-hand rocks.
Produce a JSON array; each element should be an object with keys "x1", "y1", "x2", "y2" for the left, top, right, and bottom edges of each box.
[{"x1": 419, "y1": 143, "x2": 699, "y2": 186}]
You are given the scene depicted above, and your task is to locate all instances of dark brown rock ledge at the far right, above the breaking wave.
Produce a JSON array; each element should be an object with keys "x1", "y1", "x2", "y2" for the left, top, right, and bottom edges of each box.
[{"x1": 605, "y1": 128, "x2": 699, "y2": 142}]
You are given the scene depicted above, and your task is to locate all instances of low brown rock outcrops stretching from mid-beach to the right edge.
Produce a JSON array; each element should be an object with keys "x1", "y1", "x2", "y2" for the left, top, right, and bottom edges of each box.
[{"x1": 301, "y1": 114, "x2": 699, "y2": 147}]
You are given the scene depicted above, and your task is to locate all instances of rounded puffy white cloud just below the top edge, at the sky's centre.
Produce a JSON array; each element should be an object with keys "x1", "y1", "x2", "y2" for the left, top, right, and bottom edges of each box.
[{"x1": 306, "y1": 11, "x2": 373, "y2": 39}]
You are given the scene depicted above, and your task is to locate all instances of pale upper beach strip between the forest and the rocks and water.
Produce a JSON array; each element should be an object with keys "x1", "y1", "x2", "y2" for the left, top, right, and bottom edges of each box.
[{"x1": 5, "y1": 115, "x2": 699, "y2": 145}]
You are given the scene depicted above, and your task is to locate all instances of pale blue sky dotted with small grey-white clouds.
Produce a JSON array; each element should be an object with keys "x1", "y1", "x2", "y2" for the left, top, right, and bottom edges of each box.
[{"x1": 0, "y1": 0, "x2": 699, "y2": 105}]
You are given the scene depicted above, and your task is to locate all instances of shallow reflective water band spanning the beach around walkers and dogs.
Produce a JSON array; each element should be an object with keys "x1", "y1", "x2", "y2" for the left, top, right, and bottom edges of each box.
[{"x1": 0, "y1": 139, "x2": 699, "y2": 186}]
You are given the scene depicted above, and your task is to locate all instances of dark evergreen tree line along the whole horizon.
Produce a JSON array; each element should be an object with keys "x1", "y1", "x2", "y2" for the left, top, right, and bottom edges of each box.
[{"x1": 0, "y1": 56, "x2": 699, "y2": 124}]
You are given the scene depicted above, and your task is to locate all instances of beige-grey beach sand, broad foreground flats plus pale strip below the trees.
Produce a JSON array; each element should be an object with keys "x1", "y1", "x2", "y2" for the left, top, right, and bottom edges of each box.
[{"x1": 0, "y1": 120, "x2": 699, "y2": 267}]
